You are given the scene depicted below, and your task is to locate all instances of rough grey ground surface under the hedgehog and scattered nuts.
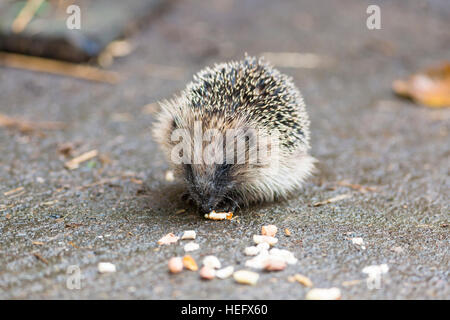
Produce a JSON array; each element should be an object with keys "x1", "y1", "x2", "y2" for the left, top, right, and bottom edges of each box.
[{"x1": 0, "y1": 0, "x2": 450, "y2": 299}]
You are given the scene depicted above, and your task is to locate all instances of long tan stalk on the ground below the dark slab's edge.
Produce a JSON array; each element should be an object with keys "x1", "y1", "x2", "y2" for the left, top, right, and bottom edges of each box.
[{"x1": 0, "y1": 52, "x2": 119, "y2": 84}]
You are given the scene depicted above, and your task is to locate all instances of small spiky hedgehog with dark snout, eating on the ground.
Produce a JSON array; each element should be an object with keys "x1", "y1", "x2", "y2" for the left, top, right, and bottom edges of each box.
[{"x1": 153, "y1": 55, "x2": 316, "y2": 213}]
